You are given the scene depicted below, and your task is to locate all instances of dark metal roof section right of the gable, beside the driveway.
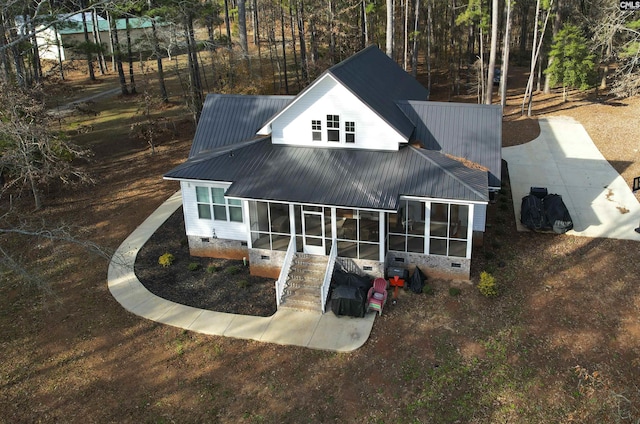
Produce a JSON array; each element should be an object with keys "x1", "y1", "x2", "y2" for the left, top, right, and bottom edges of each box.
[{"x1": 398, "y1": 101, "x2": 502, "y2": 187}]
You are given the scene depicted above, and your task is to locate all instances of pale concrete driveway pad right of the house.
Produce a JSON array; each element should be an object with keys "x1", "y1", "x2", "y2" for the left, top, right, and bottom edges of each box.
[{"x1": 502, "y1": 117, "x2": 640, "y2": 241}]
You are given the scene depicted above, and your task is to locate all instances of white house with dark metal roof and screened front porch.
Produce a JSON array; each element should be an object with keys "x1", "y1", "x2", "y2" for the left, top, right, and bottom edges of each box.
[{"x1": 165, "y1": 46, "x2": 502, "y2": 309}]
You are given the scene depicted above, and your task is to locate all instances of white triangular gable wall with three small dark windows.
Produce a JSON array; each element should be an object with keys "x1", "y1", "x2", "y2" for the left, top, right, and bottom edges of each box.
[{"x1": 258, "y1": 73, "x2": 408, "y2": 150}]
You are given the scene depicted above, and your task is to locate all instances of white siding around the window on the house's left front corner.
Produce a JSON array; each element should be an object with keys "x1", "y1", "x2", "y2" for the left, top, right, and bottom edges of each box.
[{"x1": 180, "y1": 181, "x2": 249, "y2": 241}]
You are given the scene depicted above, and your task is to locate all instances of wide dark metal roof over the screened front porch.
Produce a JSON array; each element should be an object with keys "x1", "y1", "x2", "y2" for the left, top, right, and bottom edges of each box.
[{"x1": 165, "y1": 138, "x2": 488, "y2": 210}]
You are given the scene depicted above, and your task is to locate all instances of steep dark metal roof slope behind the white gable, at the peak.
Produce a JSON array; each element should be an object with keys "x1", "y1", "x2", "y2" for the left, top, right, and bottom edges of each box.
[{"x1": 327, "y1": 46, "x2": 429, "y2": 138}]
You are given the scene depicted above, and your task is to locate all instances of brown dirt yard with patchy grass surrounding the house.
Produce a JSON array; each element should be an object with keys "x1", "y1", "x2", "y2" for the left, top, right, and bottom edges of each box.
[{"x1": 0, "y1": 64, "x2": 640, "y2": 423}]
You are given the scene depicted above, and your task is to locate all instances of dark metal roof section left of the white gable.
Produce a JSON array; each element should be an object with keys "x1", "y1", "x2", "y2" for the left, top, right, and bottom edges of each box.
[{"x1": 189, "y1": 94, "x2": 293, "y2": 157}]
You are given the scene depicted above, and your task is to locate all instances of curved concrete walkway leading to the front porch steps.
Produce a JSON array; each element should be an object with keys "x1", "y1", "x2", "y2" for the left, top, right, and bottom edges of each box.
[{"x1": 107, "y1": 192, "x2": 375, "y2": 352}]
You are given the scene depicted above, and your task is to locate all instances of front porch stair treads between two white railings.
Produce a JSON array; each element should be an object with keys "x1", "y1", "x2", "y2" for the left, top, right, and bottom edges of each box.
[{"x1": 280, "y1": 253, "x2": 328, "y2": 312}]
